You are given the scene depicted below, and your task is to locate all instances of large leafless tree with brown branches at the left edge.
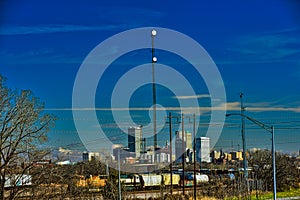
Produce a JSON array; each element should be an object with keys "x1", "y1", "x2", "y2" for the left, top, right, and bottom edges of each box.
[{"x1": 0, "y1": 75, "x2": 55, "y2": 199}]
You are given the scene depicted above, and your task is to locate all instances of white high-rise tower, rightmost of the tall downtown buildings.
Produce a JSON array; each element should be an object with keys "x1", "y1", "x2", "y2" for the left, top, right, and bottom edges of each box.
[{"x1": 196, "y1": 137, "x2": 211, "y2": 162}]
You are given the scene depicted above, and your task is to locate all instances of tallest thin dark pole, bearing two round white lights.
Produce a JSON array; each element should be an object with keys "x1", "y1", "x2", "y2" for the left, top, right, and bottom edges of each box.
[{"x1": 151, "y1": 29, "x2": 157, "y2": 163}]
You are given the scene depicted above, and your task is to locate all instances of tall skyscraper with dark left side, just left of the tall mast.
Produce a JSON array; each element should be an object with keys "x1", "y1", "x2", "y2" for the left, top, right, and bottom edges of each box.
[{"x1": 128, "y1": 125, "x2": 142, "y2": 158}]
